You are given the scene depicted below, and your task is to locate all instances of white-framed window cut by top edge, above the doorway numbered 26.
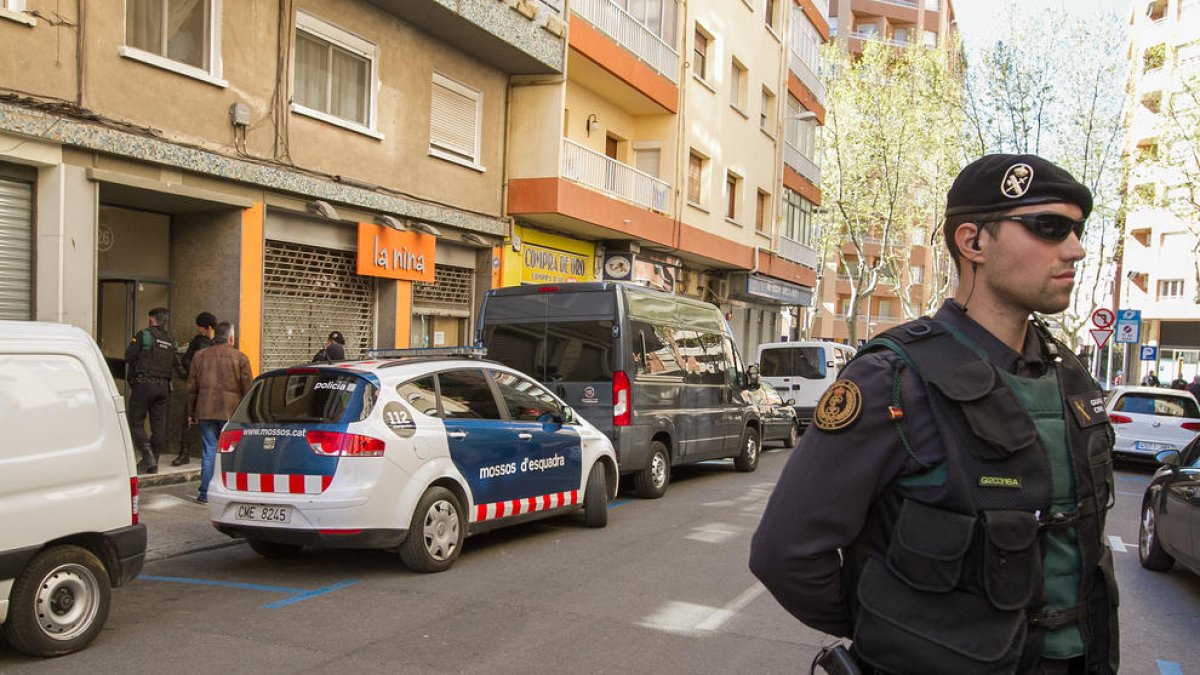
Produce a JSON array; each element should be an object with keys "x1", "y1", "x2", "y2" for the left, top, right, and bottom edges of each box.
[{"x1": 123, "y1": 0, "x2": 224, "y2": 85}]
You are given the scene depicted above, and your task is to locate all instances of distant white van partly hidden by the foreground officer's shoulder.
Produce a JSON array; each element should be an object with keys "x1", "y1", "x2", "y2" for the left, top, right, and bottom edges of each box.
[{"x1": 756, "y1": 341, "x2": 854, "y2": 426}]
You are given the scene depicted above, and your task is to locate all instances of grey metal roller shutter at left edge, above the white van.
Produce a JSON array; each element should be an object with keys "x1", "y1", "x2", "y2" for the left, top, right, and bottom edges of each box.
[{"x1": 0, "y1": 179, "x2": 34, "y2": 321}]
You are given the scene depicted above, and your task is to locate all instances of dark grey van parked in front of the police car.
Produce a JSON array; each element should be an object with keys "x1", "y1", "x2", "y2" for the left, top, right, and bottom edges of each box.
[{"x1": 478, "y1": 282, "x2": 760, "y2": 498}]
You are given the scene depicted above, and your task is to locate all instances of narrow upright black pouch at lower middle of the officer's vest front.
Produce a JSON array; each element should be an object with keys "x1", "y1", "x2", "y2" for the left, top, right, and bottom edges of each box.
[{"x1": 983, "y1": 510, "x2": 1042, "y2": 610}]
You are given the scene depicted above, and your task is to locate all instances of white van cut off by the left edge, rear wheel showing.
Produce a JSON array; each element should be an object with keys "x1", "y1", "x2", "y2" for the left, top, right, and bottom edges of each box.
[{"x1": 0, "y1": 321, "x2": 146, "y2": 656}]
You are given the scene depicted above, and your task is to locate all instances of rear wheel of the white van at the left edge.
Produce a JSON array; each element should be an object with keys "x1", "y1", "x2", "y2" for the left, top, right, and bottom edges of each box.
[{"x1": 4, "y1": 546, "x2": 113, "y2": 656}]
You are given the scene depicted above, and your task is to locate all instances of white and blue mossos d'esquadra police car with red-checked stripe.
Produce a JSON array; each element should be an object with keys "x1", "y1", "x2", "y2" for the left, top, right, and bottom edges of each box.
[{"x1": 209, "y1": 350, "x2": 618, "y2": 572}]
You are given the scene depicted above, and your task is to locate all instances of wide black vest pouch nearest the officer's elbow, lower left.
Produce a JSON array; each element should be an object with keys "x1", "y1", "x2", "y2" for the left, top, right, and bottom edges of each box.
[{"x1": 888, "y1": 500, "x2": 976, "y2": 593}]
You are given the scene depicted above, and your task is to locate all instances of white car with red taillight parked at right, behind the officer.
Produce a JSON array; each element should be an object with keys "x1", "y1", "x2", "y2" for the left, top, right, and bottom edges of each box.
[{"x1": 1106, "y1": 386, "x2": 1200, "y2": 461}]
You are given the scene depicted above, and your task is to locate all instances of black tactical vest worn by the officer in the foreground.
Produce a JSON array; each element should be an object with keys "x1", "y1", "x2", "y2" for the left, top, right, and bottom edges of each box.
[{"x1": 847, "y1": 319, "x2": 1118, "y2": 674}]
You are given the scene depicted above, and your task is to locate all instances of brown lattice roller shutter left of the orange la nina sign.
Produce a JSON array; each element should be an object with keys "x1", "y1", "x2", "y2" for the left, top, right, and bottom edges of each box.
[{"x1": 263, "y1": 240, "x2": 376, "y2": 370}]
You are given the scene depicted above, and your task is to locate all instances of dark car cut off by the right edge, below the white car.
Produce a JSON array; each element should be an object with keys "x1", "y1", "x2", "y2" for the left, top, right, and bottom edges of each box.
[{"x1": 1138, "y1": 438, "x2": 1200, "y2": 574}]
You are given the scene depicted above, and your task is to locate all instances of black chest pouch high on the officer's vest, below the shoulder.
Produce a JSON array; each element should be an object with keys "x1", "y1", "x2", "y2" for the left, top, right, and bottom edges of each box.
[{"x1": 932, "y1": 360, "x2": 1038, "y2": 461}]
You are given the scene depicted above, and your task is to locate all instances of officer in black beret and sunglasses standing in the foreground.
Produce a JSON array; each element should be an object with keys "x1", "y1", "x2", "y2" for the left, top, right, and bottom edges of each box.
[{"x1": 750, "y1": 155, "x2": 1118, "y2": 674}]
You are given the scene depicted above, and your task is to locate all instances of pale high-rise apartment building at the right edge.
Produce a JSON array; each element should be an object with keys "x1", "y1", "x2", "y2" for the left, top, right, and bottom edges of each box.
[{"x1": 1115, "y1": 0, "x2": 1200, "y2": 384}]
